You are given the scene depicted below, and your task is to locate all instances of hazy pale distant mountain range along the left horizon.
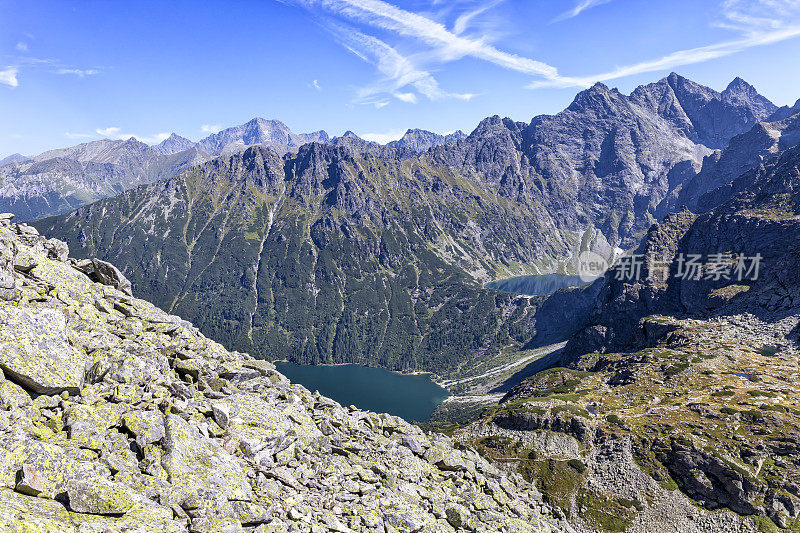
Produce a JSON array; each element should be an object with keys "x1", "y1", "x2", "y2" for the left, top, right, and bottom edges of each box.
[{"x1": 0, "y1": 118, "x2": 464, "y2": 221}]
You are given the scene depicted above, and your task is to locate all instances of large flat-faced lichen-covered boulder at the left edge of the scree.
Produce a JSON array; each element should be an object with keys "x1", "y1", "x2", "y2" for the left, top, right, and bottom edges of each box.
[{"x1": 0, "y1": 307, "x2": 86, "y2": 394}]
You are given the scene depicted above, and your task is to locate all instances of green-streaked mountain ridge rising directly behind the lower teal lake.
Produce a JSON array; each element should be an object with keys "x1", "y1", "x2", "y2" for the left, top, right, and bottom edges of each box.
[{"x1": 37, "y1": 144, "x2": 564, "y2": 374}]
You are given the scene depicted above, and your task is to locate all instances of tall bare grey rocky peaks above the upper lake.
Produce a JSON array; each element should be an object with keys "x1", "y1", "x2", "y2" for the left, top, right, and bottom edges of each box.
[{"x1": 429, "y1": 73, "x2": 775, "y2": 247}]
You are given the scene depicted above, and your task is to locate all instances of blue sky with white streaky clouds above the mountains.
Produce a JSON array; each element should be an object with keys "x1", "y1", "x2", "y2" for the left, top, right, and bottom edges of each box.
[{"x1": 0, "y1": 0, "x2": 800, "y2": 157}]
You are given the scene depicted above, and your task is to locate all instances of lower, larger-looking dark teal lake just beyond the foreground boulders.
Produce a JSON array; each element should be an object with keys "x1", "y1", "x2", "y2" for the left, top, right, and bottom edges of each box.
[{"x1": 275, "y1": 362, "x2": 450, "y2": 422}]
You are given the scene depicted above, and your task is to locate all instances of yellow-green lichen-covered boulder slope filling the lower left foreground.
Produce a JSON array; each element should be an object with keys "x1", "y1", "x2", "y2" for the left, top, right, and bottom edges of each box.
[{"x1": 0, "y1": 215, "x2": 566, "y2": 533}]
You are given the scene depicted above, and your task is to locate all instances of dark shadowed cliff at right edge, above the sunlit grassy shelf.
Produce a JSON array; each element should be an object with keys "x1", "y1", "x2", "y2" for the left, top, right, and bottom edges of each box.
[{"x1": 565, "y1": 141, "x2": 800, "y2": 357}]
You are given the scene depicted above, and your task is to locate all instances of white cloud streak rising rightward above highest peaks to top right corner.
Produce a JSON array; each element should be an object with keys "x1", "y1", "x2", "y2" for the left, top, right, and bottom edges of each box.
[{"x1": 528, "y1": 0, "x2": 800, "y2": 89}]
